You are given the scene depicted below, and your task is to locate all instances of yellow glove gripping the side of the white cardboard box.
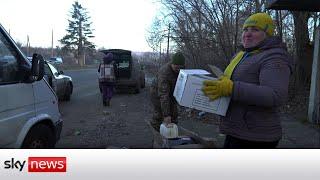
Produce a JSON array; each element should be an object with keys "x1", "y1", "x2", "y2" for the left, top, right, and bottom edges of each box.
[{"x1": 202, "y1": 76, "x2": 233, "y2": 100}]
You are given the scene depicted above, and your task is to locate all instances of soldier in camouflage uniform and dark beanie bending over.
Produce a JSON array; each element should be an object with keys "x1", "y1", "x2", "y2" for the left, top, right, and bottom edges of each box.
[{"x1": 150, "y1": 52, "x2": 185, "y2": 131}]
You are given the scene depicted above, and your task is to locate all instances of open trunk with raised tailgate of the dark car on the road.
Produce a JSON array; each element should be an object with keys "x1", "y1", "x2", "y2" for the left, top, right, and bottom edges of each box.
[{"x1": 101, "y1": 49, "x2": 132, "y2": 79}]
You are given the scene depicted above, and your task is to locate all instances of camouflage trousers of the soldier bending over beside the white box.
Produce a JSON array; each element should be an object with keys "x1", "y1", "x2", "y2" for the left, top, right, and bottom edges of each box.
[{"x1": 150, "y1": 90, "x2": 178, "y2": 131}]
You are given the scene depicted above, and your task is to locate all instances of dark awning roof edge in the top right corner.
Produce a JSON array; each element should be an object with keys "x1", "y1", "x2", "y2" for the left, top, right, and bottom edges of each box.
[{"x1": 267, "y1": 0, "x2": 320, "y2": 12}]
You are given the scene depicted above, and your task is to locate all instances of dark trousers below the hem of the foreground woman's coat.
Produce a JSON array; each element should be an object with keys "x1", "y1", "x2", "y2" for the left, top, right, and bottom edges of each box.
[{"x1": 223, "y1": 135, "x2": 279, "y2": 149}]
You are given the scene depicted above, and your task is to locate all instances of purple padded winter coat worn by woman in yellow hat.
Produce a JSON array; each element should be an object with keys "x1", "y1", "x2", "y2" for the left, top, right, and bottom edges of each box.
[{"x1": 220, "y1": 37, "x2": 292, "y2": 142}]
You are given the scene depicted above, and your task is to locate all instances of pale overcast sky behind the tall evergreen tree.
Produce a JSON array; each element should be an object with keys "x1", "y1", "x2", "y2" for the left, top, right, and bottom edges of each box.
[{"x1": 0, "y1": 0, "x2": 158, "y2": 51}]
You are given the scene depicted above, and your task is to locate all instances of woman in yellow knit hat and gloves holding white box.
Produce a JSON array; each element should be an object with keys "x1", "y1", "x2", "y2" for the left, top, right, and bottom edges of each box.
[{"x1": 203, "y1": 13, "x2": 292, "y2": 148}]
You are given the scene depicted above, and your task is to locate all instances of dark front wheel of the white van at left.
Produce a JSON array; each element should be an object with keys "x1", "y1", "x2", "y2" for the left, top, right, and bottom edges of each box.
[{"x1": 22, "y1": 124, "x2": 55, "y2": 149}]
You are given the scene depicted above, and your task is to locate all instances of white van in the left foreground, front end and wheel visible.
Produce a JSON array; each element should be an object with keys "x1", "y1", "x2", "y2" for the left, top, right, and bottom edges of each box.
[{"x1": 0, "y1": 25, "x2": 62, "y2": 148}]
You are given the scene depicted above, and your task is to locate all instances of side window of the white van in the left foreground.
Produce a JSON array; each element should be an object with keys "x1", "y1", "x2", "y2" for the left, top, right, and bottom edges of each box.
[{"x1": 0, "y1": 33, "x2": 18, "y2": 84}]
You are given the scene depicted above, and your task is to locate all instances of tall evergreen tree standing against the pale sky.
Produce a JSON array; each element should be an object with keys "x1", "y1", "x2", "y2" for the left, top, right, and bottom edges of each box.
[{"x1": 60, "y1": 1, "x2": 95, "y2": 65}]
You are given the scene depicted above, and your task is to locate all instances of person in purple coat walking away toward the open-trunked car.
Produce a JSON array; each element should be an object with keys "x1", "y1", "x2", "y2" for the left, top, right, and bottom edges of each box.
[{"x1": 98, "y1": 53, "x2": 115, "y2": 106}]
